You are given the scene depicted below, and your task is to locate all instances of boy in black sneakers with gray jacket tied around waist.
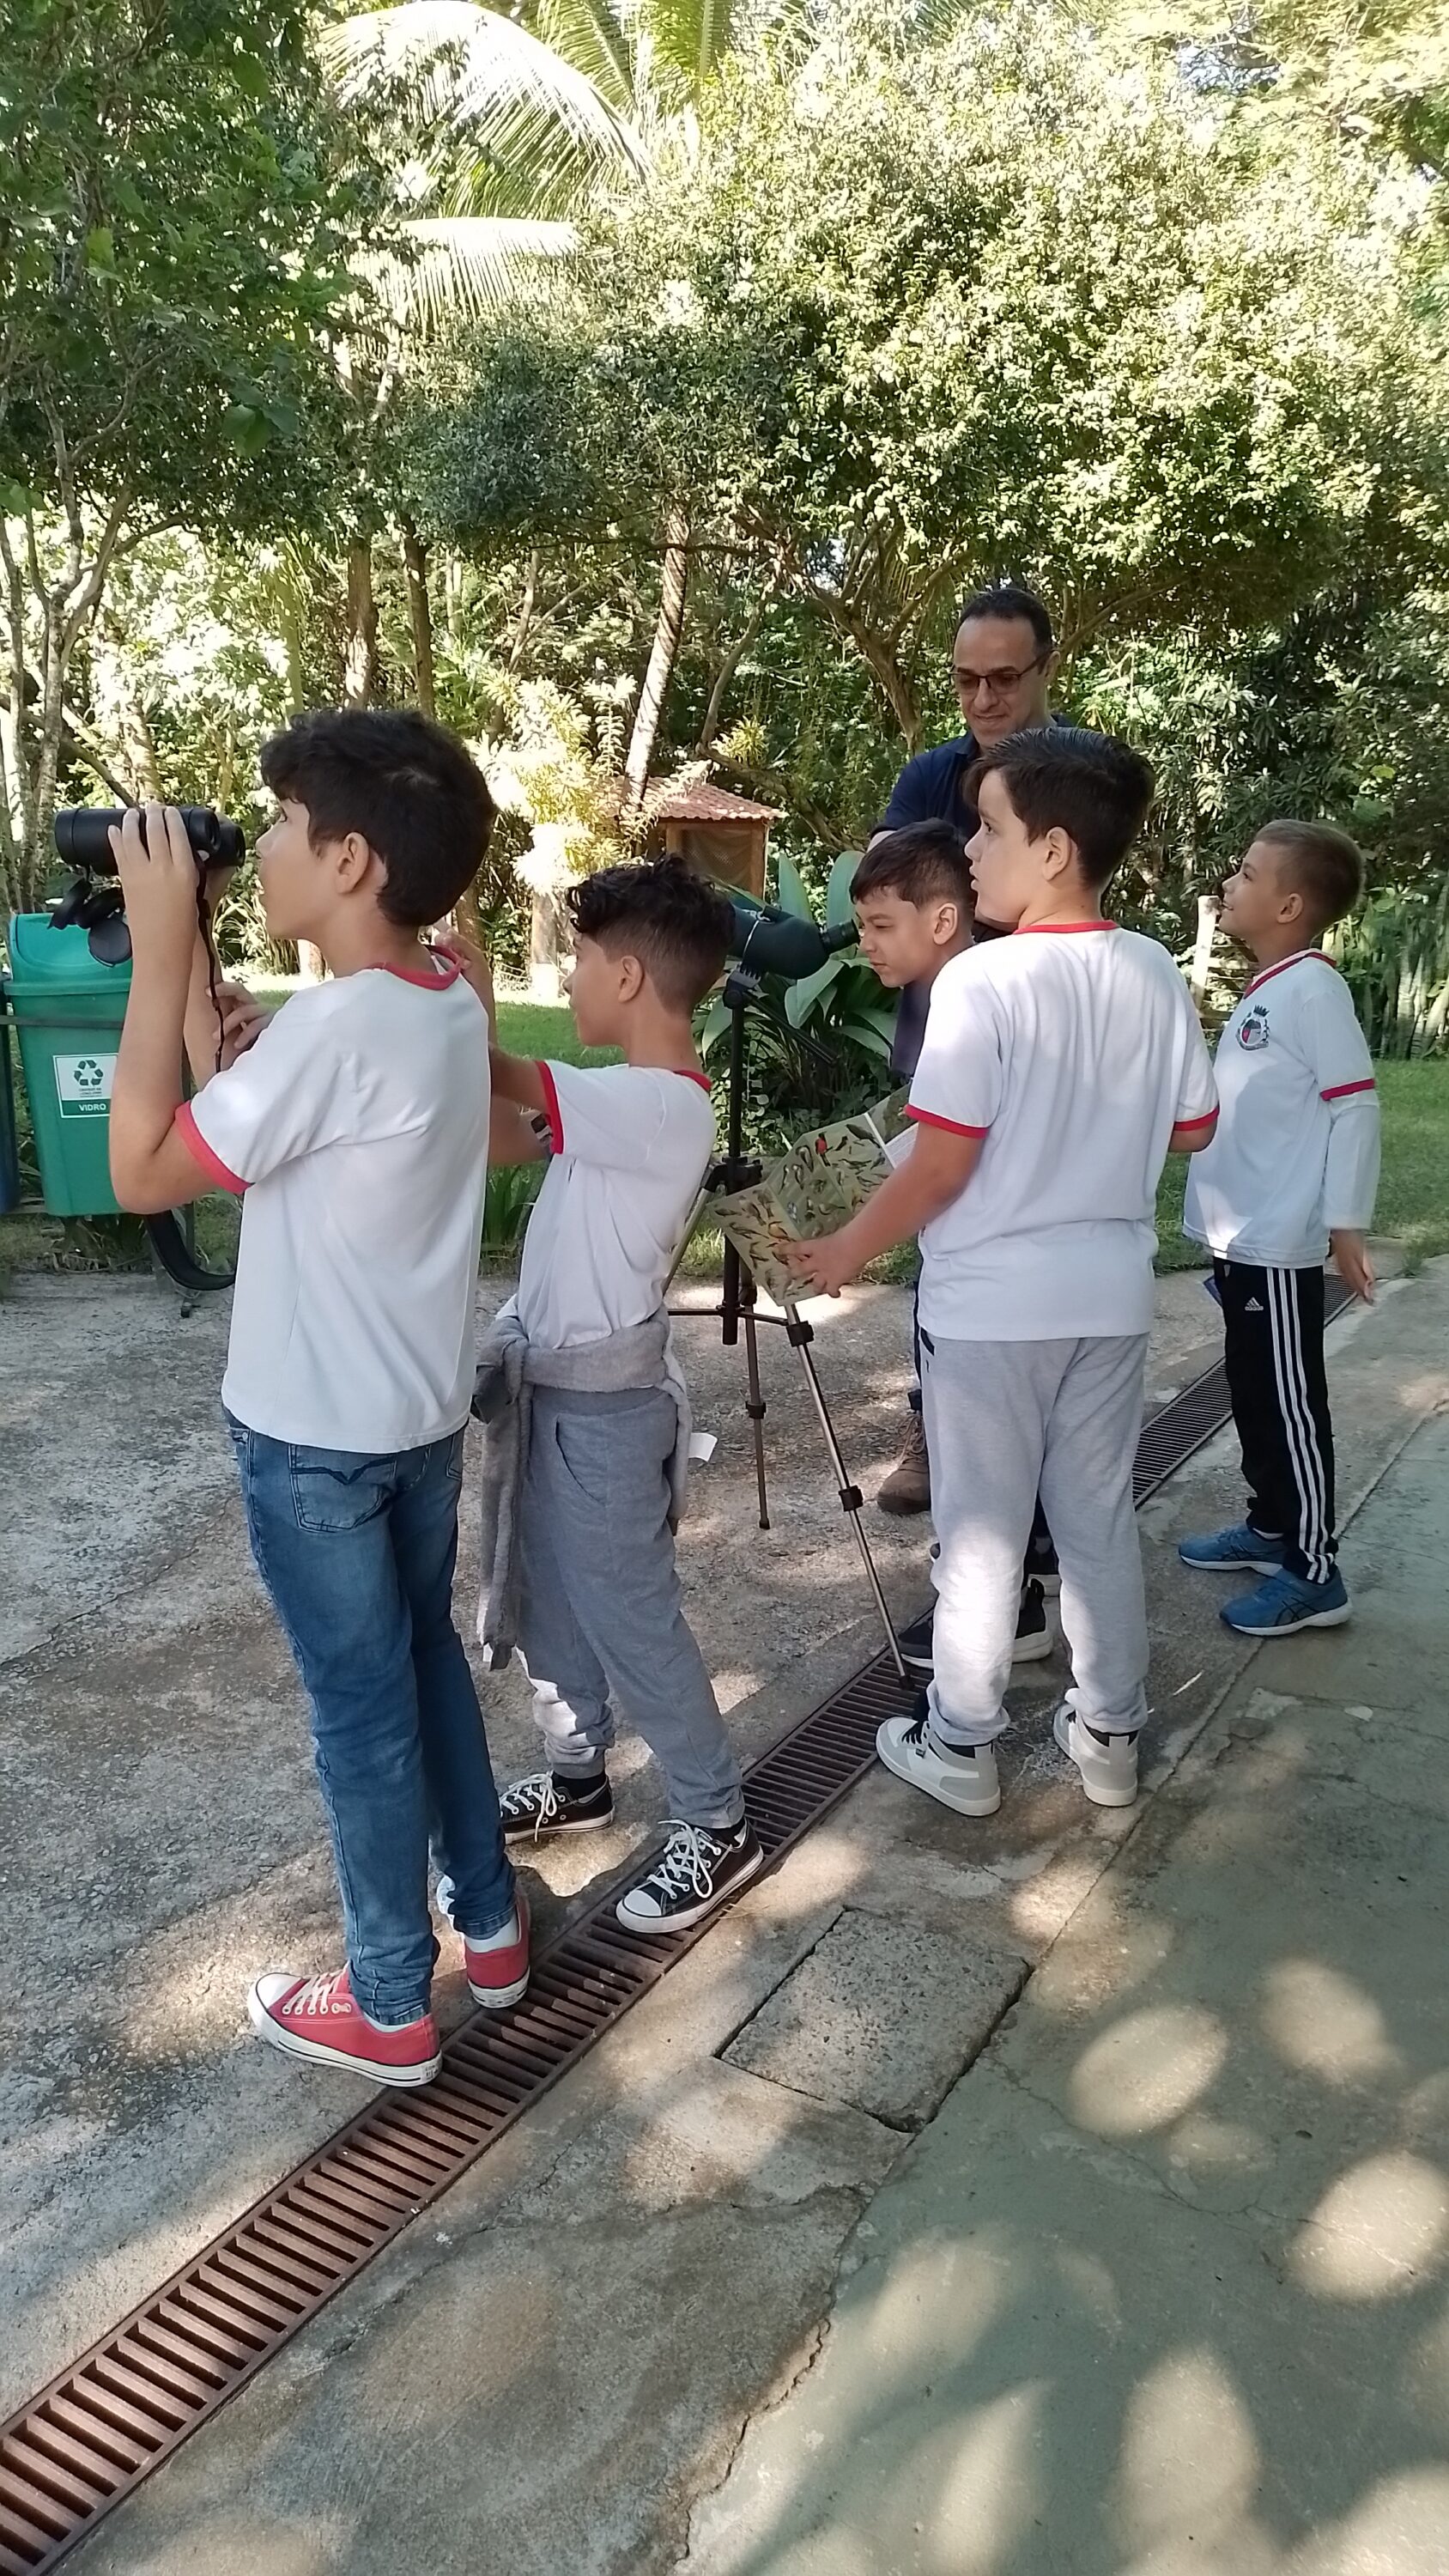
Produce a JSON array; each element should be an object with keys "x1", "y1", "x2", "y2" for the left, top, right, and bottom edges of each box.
[{"x1": 479, "y1": 860, "x2": 764, "y2": 1932}]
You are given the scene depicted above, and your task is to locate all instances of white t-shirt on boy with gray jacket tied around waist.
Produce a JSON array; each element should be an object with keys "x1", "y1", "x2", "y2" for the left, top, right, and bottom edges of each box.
[{"x1": 518, "y1": 1064, "x2": 716, "y2": 1350}]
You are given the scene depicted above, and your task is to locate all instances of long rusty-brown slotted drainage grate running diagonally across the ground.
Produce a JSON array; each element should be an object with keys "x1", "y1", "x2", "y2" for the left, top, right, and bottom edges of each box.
[{"x1": 0, "y1": 1329, "x2": 1346, "y2": 2576}]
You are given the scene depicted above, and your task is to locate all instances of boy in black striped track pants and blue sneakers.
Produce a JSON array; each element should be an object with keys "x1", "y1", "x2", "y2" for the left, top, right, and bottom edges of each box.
[{"x1": 1179, "y1": 822, "x2": 1379, "y2": 1636}]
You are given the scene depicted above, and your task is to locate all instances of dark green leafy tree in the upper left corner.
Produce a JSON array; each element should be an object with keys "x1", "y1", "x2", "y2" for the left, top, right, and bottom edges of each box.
[{"x1": 0, "y1": 0, "x2": 366, "y2": 904}]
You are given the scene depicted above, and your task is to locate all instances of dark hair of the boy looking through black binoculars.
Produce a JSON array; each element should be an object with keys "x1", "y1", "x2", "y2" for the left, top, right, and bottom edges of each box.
[{"x1": 263, "y1": 706, "x2": 494, "y2": 930}]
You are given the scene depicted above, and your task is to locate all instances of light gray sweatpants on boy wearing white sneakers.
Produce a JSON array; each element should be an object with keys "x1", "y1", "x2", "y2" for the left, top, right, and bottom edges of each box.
[{"x1": 921, "y1": 1334, "x2": 1148, "y2": 1744}]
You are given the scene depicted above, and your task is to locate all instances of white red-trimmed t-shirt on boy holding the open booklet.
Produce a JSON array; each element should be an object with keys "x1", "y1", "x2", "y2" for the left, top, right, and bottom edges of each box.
[{"x1": 908, "y1": 922, "x2": 1217, "y2": 1342}]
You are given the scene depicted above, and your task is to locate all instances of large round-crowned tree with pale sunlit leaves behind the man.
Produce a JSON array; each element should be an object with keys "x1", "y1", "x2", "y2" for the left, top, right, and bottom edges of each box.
[{"x1": 415, "y1": 8, "x2": 1446, "y2": 819}]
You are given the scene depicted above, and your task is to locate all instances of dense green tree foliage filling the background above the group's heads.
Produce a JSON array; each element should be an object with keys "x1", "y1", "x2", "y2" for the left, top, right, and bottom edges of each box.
[{"x1": 0, "y1": 0, "x2": 1449, "y2": 1072}]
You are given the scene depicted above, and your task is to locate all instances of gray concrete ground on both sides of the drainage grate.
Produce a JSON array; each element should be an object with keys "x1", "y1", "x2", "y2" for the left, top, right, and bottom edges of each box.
[{"x1": 0, "y1": 1267, "x2": 1449, "y2": 2576}]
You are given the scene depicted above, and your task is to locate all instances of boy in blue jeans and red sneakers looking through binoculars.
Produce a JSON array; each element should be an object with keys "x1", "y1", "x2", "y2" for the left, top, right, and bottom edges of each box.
[{"x1": 111, "y1": 711, "x2": 528, "y2": 2084}]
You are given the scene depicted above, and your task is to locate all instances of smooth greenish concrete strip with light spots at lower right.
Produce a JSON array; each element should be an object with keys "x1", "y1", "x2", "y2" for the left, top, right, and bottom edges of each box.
[{"x1": 682, "y1": 1309, "x2": 1449, "y2": 2576}]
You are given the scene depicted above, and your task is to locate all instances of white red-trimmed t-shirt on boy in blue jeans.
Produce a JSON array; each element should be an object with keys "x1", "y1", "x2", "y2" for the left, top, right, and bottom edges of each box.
[{"x1": 178, "y1": 966, "x2": 489, "y2": 1458}]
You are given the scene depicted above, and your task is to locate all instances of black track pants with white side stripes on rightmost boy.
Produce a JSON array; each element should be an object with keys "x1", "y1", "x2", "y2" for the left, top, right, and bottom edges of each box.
[{"x1": 1212, "y1": 1260, "x2": 1338, "y2": 1584}]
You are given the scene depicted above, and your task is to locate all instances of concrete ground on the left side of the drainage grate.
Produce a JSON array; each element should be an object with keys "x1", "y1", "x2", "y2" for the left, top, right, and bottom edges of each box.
[{"x1": 0, "y1": 1257, "x2": 1212, "y2": 2416}]
